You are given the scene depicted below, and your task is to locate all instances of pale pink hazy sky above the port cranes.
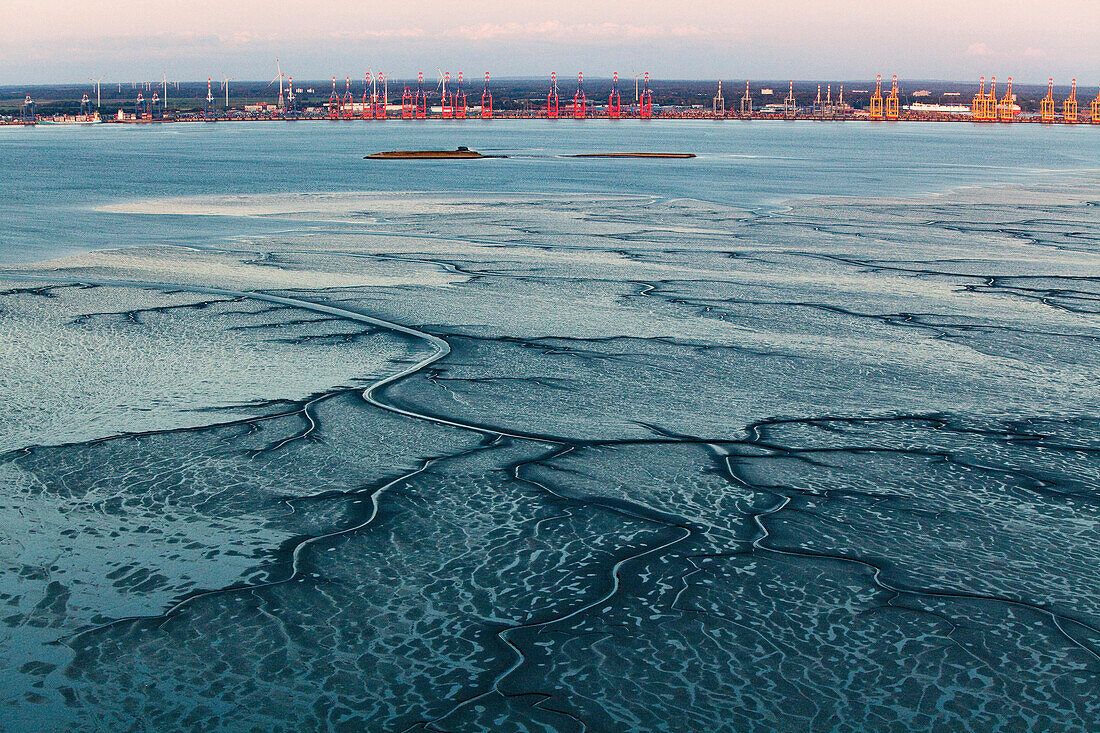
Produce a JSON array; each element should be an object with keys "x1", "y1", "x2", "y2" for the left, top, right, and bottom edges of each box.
[{"x1": 0, "y1": 0, "x2": 1100, "y2": 88}]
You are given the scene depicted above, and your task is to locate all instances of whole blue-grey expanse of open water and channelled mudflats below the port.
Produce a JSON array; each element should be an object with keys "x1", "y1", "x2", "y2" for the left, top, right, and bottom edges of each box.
[{"x1": 0, "y1": 120, "x2": 1100, "y2": 733}]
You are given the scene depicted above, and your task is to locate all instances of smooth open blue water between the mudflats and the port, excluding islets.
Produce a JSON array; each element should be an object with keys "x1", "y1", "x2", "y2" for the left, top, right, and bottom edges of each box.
[{"x1": 0, "y1": 120, "x2": 1100, "y2": 262}]
